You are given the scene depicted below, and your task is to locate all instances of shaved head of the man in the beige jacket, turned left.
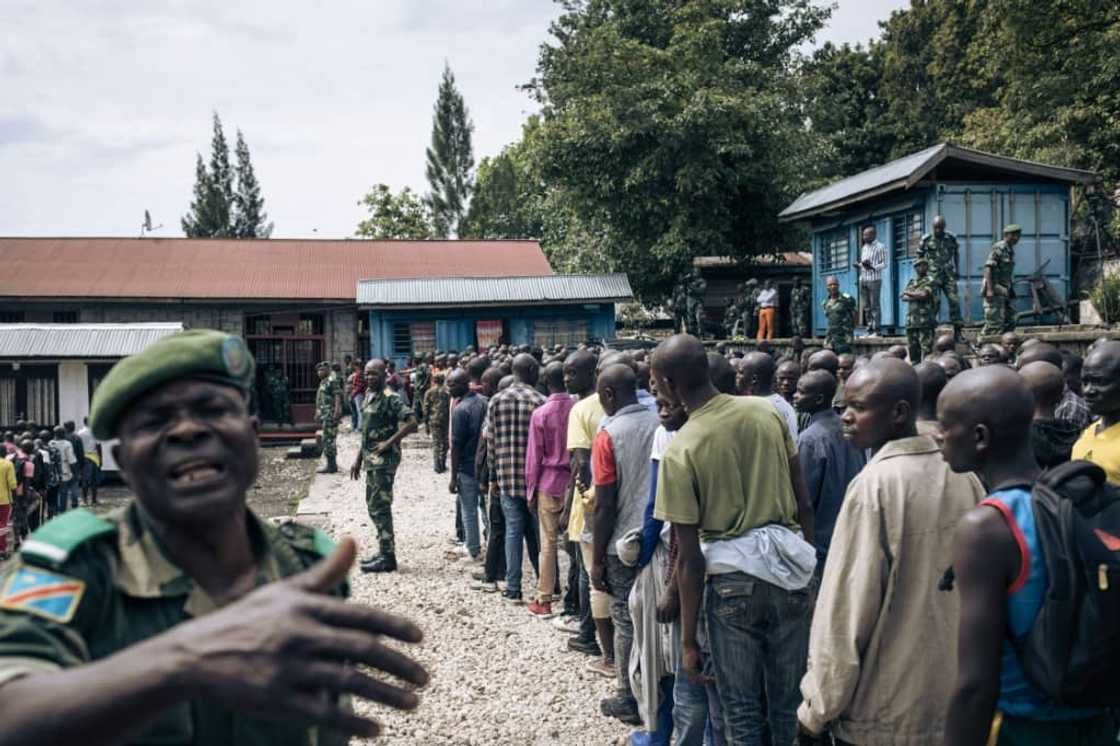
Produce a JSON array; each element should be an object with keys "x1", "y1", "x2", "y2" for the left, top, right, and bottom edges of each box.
[{"x1": 841, "y1": 355, "x2": 922, "y2": 449}]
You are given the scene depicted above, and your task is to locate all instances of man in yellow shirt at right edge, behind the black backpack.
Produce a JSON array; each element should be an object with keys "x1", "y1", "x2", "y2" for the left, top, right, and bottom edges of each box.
[{"x1": 1073, "y1": 341, "x2": 1120, "y2": 484}]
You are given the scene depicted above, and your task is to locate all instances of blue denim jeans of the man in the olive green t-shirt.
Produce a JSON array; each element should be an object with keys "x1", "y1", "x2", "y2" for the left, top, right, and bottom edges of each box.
[{"x1": 704, "y1": 572, "x2": 813, "y2": 746}]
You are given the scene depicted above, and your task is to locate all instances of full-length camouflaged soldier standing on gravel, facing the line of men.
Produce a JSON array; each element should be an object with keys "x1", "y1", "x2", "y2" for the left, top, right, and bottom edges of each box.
[{"x1": 351, "y1": 358, "x2": 417, "y2": 572}]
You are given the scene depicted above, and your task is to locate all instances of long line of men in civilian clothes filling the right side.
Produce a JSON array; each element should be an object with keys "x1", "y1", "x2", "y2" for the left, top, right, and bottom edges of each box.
[{"x1": 380, "y1": 334, "x2": 1120, "y2": 746}]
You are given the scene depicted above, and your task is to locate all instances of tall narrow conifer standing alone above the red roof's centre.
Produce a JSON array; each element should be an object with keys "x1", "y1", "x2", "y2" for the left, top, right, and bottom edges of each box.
[{"x1": 426, "y1": 64, "x2": 475, "y2": 237}]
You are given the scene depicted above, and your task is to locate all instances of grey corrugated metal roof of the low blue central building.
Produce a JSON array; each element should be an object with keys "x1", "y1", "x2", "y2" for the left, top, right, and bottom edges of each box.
[{"x1": 357, "y1": 274, "x2": 634, "y2": 308}]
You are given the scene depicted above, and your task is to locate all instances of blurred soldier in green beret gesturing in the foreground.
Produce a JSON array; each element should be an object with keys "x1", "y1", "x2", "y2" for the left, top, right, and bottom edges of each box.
[{"x1": 0, "y1": 329, "x2": 427, "y2": 746}]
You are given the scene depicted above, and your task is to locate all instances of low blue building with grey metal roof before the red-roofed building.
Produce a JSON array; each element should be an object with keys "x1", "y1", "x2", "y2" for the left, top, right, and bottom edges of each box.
[{"x1": 357, "y1": 274, "x2": 634, "y2": 365}]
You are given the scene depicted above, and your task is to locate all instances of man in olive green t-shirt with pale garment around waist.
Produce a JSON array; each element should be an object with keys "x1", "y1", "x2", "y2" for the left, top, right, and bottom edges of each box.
[{"x1": 652, "y1": 335, "x2": 815, "y2": 744}]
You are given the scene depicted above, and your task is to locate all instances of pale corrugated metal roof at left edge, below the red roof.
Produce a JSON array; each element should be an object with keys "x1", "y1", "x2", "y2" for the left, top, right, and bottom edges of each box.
[{"x1": 0, "y1": 323, "x2": 183, "y2": 358}]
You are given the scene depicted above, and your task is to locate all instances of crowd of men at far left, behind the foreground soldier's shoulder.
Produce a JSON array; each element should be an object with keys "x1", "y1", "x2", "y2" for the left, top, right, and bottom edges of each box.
[{"x1": 0, "y1": 420, "x2": 102, "y2": 558}]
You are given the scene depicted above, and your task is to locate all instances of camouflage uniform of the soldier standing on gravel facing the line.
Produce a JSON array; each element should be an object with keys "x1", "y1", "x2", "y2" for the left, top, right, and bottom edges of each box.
[{"x1": 362, "y1": 386, "x2": 416, "y2": 557}]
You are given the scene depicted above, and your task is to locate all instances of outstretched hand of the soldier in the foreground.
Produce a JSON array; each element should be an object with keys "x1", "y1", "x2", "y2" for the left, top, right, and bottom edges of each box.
[{"x1": 167, "y1": 538, "x2": 429, "y2": 736}]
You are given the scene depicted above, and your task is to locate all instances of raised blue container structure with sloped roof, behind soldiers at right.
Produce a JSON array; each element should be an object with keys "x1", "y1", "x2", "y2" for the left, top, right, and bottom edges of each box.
[{"x1": 780, "y1": 143, "x2": 1095, "y2": 336}]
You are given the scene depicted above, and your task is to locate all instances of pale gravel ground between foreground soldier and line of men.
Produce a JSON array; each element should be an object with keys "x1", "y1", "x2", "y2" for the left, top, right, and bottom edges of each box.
[{"x1": 310, "y1": 432, "x2": 629, "y2": 745}]
